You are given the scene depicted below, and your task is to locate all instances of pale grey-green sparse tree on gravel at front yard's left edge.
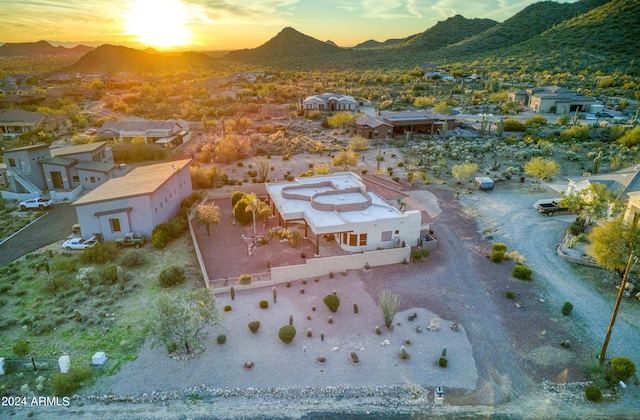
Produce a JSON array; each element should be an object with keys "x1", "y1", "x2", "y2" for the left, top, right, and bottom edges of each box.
[{"x1": 151, "y1": 289, "x2": 222, "y2": 354}]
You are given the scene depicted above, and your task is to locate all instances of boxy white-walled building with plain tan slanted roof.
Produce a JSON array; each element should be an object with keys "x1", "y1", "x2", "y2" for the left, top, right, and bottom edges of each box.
[{"x1": 73, "y1": 159, "x2": 193, "y2": 241}]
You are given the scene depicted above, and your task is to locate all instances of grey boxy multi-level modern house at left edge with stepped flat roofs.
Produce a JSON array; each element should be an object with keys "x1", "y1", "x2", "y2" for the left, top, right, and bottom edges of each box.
[{"x1": 4, "y1": 142, "x2": 115, "y2": 196}]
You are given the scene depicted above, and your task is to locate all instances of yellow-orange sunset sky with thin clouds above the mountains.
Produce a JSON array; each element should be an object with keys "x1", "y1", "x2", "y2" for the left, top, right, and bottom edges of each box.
[{"x1": 0, "y1": 0, "x2": 580, "y2": 50}]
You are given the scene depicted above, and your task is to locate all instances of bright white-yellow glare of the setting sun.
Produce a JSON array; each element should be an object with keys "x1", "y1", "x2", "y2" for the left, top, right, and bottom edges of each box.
[{"x1": 124, "y1": 0, "x2": 191, "y2": 48}]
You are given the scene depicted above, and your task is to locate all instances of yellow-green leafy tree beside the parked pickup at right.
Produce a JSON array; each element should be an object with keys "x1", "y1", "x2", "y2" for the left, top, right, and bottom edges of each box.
[{"x1": 559, "y1": 184, "x2": 624, "y2": 227}]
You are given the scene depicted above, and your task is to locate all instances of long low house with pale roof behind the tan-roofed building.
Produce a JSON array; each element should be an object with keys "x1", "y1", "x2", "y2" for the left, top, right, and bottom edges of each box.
[{"x1": 97, "y1": 120, "x2": 191, "y2": 147}]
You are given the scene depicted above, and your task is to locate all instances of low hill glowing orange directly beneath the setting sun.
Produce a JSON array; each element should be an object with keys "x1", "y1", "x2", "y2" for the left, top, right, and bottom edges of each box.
[{"x1": 67, "y1": 44, "x2": 213, "y2": 73}]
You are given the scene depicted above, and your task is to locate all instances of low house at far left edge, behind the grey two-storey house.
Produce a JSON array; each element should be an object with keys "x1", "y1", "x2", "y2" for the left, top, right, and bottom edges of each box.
[{"x1": 0, "y1": 111, "x2": 71, "y2": 137}]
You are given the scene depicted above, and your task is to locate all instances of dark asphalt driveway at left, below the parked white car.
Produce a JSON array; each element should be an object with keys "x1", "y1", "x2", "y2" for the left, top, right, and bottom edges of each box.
[{"x1": 0, "y1": 204, "x2": 78, "y2": 266}]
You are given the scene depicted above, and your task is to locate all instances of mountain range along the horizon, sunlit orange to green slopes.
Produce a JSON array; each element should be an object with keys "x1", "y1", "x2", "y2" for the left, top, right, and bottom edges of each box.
[{"x1": 0, "y1": 0, "x2": 640, "y2": 74}]
